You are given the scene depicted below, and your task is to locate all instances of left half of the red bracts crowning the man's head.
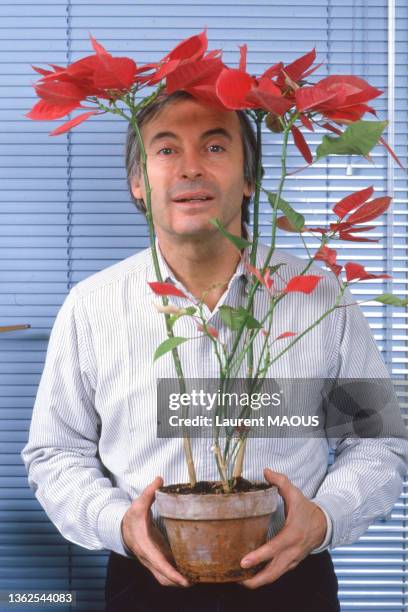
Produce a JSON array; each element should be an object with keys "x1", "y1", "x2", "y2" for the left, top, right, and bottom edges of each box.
[{"x1": 26, "y1": 31, "x2": 224, "y2": 136}]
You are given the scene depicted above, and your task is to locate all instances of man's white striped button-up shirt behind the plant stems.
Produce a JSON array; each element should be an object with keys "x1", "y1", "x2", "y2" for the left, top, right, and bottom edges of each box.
[{"x1": 21, "y1": 242, "x2": 408, "y2": 555}]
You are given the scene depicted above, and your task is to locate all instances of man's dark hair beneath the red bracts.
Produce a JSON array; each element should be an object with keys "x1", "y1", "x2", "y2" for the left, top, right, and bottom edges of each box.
[{"x1": 126, "y1": 91, "x2": 256, "y2": 224}]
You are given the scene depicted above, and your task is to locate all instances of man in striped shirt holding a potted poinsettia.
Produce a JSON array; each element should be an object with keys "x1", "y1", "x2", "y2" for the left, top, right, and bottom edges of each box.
[{"x1": 22, "y1": 88, "x2": 408, "y2": 612}]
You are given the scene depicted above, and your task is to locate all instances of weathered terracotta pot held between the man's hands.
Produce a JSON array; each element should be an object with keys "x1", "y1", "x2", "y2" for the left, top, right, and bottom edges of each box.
[{"x1": 156, "y1": 487, "x2": 278, "y2": 582}]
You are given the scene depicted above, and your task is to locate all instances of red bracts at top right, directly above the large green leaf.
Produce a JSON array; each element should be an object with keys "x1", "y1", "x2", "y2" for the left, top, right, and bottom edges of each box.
[{"x1": 295, "y1": 75, "x2": 383, "y2": 123}]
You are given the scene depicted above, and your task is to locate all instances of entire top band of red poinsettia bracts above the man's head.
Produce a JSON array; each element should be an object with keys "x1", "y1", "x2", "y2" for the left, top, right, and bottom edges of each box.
[{"x1": 27, "y1": 30, "x2": 381, "y2": 143}]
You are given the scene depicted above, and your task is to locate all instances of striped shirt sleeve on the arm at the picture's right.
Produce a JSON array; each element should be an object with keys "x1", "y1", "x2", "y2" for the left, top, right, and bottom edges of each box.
[{"x1": 311, "y1": 290, "x2": 408, "y2": 549}]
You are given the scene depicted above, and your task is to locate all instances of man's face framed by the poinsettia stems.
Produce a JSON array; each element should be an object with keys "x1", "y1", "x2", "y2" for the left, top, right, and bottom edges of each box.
[{"x1": 132, "y1": 100, "x2": 251, "y2": 238}]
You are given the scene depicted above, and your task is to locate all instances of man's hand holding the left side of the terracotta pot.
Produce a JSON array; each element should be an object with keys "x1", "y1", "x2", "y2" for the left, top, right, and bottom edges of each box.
[{"x1": 122, "y1": 476, "x2": 189, "y2": 587}]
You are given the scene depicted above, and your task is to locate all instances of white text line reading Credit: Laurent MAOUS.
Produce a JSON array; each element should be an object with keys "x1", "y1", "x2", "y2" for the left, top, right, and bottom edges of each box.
[{"x1": 169, "y1": 414, "x2": 319, "y2": 427}]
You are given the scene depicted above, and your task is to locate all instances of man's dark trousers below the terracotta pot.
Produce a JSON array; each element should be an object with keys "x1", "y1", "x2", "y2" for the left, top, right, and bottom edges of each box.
[{"x1": 105, "y1": 551, "x2": 340, "y2": 612}]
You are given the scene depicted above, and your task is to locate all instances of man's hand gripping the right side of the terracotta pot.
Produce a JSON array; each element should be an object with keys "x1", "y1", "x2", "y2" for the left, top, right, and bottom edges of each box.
[{"x1": 241, "y1": 468, "x2": 327, "y2": 589}]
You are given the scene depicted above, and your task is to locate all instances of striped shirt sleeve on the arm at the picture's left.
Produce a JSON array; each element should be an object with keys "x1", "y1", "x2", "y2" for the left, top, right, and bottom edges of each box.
[{"x1": 21, "y1": 287, "x2": 132, "y2": 556}]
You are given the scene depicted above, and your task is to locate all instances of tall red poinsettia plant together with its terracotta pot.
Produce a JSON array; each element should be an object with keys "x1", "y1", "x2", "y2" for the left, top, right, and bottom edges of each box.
[{"x1": 27, "y1": 31, "x2": 407, "y2": 582}]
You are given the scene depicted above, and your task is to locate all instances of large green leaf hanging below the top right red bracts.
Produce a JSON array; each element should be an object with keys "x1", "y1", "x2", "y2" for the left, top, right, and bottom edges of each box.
[{"x1": 316, "y1": 121, "x2": 388, "y2": 159}]
